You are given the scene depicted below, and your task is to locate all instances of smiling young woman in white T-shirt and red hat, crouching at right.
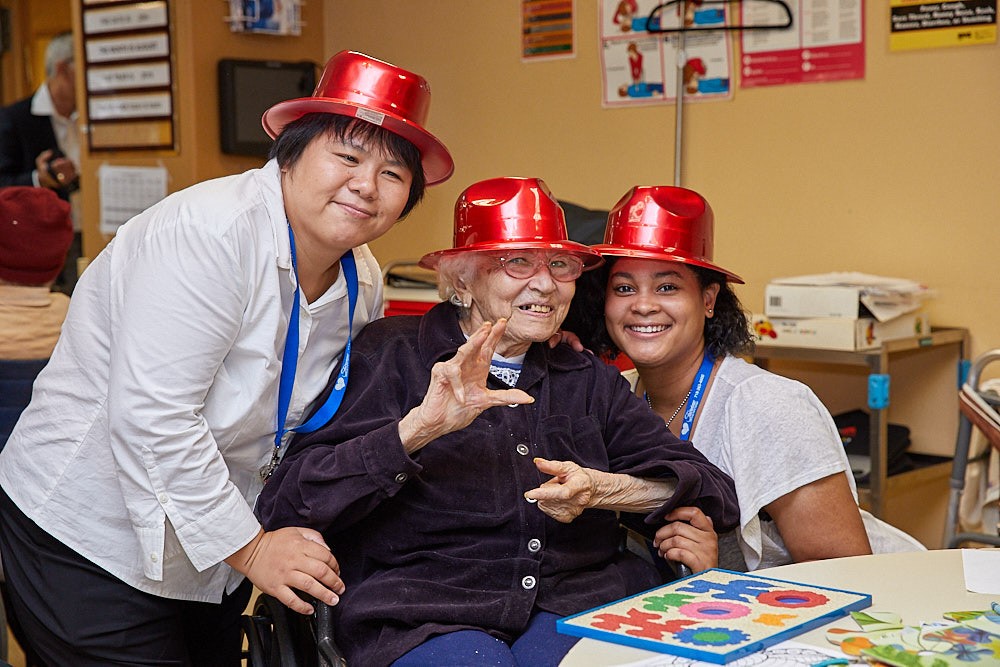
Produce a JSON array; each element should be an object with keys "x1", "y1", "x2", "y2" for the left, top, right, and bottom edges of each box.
[{"x1": 564, "y1": 186, "x2": 922, "y2": 570}]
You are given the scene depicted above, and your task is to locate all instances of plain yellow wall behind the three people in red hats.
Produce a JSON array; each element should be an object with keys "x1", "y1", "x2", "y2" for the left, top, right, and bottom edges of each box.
[{"x1": 326, "y1": 0, "x2": 1000, "y2": 362}]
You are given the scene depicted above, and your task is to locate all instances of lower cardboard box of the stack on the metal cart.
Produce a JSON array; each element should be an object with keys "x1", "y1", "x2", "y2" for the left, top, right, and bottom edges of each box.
[{"x1": 750, "y1": 310, "x2": 931, "y2": 351}]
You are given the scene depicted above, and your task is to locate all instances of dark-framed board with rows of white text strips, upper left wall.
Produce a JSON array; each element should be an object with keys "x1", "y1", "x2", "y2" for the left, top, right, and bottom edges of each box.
[{"x1": 81, "y1": 0, "x2": 175, "y2": 153}]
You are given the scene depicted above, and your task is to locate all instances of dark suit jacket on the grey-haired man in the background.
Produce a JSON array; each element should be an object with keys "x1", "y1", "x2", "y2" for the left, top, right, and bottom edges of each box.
[{"x1": 0, "y1": 97, "x2": 69, "y2": 199}]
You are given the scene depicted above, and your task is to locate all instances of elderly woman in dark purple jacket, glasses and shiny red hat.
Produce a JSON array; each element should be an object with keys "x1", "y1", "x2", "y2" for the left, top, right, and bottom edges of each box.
[{"x1": 258, "y1": 178, "x2": 738, "y2": 666}]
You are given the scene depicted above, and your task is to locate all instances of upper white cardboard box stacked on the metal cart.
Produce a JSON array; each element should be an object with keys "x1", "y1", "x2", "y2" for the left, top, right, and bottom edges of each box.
[{"x1": 764, "y1": 283, "x2": 921, "y2": 320}]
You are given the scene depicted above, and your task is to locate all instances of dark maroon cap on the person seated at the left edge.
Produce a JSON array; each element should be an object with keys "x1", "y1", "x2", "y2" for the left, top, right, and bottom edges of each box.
[{"x1": 0, "y1": 185, "x2": 73, "y2": 285}]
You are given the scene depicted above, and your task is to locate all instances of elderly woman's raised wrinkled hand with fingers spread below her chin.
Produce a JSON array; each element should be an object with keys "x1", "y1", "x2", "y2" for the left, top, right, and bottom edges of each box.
[{"x1": 399, "y1": 319, "x2": 535, "y2": 452}]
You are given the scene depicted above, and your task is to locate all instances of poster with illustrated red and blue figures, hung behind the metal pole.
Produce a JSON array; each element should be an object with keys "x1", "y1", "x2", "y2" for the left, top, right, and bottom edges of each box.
[{"x1": 600, "y1": 0, "x2": 732, "y2": 107}]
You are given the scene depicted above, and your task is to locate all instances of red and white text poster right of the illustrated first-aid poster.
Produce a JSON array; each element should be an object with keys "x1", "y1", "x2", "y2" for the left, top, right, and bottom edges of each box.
[{"x1": 740, "y1": 0, "x2": 865, "y2": 88}]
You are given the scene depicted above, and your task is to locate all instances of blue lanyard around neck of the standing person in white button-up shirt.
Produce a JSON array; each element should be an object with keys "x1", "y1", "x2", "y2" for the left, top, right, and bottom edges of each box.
[{"x1": 260, "y1": 225, "x2": 358, "y2": 482}]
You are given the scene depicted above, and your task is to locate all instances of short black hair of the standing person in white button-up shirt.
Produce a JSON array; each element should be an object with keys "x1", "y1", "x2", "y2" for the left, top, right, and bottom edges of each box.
[{"x1": 269, "y1": 112, "x2": 427, "y2": 220}]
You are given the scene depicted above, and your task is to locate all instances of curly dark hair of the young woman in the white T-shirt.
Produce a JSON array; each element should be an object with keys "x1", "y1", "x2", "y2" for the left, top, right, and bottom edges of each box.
[{"x1": 562, "y1": 257, "x2": 754, "y2": 359}]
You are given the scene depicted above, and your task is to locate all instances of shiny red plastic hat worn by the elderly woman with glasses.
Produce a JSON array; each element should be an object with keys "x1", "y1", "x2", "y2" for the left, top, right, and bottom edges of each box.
[{"x1": 420, "y1": 177, "x2": 602, "y2": 269}]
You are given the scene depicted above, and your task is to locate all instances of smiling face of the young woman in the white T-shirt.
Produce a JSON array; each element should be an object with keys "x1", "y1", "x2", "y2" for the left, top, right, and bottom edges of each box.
[{"x1": 604, "y1": 258, "x2": 719, "y2": 367}]
